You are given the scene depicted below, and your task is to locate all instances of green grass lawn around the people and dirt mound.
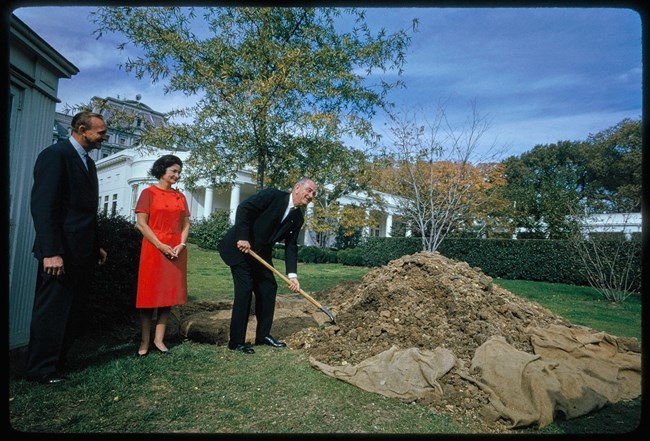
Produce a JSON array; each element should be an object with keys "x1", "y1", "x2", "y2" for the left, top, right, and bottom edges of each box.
[{"x1": 8, "y1": 245, "x2": 641, "y2": 439}]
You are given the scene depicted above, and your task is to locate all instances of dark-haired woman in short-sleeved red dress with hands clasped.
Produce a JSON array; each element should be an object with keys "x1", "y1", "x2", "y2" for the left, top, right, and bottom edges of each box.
[{"x1": 135, "y1": 155, "x2": 190, "y2": 357}]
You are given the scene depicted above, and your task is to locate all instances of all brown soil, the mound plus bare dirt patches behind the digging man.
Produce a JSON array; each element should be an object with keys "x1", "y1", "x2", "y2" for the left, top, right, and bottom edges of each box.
[{"x1": 168, "y1": 252, "x2": 640, "y2": 433}]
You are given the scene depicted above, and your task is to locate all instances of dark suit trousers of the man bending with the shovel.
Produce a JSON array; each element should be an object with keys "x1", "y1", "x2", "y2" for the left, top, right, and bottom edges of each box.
[{"x1": 229, "y1": 256, "x2": 278, "y2": 347}]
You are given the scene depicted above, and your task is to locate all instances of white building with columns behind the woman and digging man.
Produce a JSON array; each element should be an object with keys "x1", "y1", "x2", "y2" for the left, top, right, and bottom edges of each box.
[{"x1": 97, "y1": 149, "x2": 397, "y2": 245}]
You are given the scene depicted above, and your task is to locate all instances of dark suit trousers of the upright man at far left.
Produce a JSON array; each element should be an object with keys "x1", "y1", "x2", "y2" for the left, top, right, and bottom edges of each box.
[{"x1": 25, "y1": 261, "x2": 93, "y2": 378}]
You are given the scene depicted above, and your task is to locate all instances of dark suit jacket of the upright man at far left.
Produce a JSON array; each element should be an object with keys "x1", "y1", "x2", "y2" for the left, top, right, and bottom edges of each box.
[{"x1": 31, "y1": 139, "x2": 100, "y2": 264}]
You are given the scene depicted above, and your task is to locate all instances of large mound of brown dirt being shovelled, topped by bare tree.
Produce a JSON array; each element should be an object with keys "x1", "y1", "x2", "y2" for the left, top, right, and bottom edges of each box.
[{"x1": 286, "y1": 252, "x2": 628, "y2": 433}]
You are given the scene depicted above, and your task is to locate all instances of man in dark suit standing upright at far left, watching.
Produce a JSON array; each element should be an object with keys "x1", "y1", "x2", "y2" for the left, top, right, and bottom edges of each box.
[{"x1": 25, "y1": 111, "x2": 107, "y2": 384}]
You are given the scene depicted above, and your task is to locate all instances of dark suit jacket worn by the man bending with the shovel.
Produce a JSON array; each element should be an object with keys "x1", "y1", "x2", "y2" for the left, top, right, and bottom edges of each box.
[{"x1": 218, "y1": 188, "x2": 305, "y2": 273}]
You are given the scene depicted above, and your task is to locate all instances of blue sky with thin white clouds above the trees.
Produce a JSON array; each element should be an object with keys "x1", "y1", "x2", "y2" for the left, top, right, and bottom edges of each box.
[{"x1": 14, "y1": 6, "x2": 643, "y2": 160}]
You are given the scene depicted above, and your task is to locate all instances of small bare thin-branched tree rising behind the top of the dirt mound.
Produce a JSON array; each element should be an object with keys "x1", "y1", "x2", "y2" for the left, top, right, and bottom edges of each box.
[{"x1": 375, "y1": 102, "x2": 505, "y2": 251}]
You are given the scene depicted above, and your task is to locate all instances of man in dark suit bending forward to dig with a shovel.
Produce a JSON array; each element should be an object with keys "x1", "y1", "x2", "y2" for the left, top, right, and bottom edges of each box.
[{"x1": 218, "y1": 178, "x2": 316, "y2": 354}]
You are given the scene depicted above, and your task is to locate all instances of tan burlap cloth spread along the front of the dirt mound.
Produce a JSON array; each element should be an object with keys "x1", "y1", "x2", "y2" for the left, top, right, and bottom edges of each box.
[{"x1": 310, "y1": 325, "x2": 641, "y2": 428}]
